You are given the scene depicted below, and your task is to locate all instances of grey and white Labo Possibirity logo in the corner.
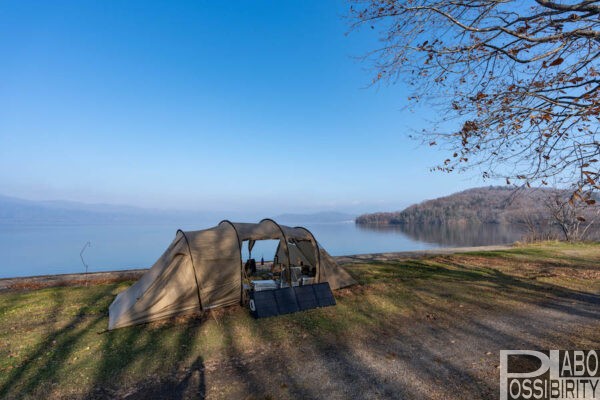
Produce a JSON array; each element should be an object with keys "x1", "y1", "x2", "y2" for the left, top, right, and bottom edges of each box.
[{"x1": 500, "y1": 350, "x2": 600, "y2": 400}]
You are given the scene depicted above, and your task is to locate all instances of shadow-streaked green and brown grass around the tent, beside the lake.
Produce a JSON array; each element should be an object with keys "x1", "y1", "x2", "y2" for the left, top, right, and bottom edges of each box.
[{"x1": 0, "y1": 243, "x2": 600, "y2": 398}]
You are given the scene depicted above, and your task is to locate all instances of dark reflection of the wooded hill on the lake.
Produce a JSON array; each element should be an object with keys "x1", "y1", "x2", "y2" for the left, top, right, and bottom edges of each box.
[{"x1": 357, "y1": 224, "x2": 526, "y2": 247}]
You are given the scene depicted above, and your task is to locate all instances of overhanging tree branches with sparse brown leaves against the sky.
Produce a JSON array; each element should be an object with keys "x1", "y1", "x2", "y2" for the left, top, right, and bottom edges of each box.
[{"x1": 351, "y1": 0, "x2": 600, "y2": 203}]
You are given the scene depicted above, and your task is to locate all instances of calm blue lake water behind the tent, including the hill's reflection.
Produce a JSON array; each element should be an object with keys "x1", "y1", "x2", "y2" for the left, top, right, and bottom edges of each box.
[{"x1": 0, "y1": 222, "x2": 523, "y2": 277}]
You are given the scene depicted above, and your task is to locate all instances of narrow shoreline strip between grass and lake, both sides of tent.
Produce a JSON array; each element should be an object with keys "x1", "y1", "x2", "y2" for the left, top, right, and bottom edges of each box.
[{"x1": 0, "y1": 245, "x2": 513, "y2": 291}]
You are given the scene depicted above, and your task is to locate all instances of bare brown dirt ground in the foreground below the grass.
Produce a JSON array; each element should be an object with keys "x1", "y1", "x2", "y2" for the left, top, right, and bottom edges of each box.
[{"x1": 168, "y1": 298, "x2": 600, "y2": 399}]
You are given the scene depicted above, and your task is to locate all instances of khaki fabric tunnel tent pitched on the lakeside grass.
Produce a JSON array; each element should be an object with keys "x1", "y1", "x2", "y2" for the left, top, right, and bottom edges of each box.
[{"x1": 108, "y1": 219, "x2": 356, "y2": 329}]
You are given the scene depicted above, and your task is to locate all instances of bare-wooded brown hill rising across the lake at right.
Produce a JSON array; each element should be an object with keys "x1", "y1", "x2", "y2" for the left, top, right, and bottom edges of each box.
[{"x1": 356, "y1": 186, "x2": 580, "y2": 225}]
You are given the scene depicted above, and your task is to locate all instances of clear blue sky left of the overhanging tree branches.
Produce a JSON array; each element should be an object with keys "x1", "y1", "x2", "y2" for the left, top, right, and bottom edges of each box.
[{"x1": 0, "y1": 0, "x2": 490, "y2": 213}]
